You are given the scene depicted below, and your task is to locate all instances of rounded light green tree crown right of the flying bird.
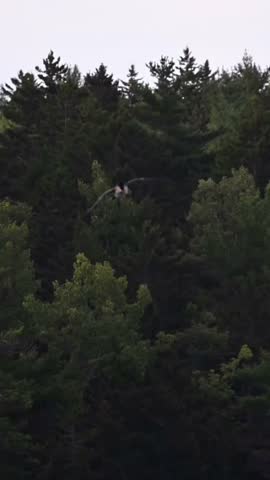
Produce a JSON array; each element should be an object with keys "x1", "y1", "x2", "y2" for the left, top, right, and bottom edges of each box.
[{"x1": 189, "y1": 167, "x2": 260, "y2": 273}]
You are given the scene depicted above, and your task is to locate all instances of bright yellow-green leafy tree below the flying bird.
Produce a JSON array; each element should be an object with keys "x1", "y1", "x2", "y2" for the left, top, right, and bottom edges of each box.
[{"x1": 20, "y1": 254, "x2": 152, "y2": 472}]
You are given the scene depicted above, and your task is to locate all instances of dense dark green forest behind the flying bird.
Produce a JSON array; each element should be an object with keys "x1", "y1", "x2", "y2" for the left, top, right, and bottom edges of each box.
[{"x1": 0, "y1": 48, "x2": 270, "y2": 480}]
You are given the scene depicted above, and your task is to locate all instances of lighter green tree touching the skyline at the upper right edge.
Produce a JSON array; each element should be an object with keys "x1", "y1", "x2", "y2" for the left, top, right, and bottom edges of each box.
[{"x1": 210, "y1": 54, "x2": 270, "y2": 187}]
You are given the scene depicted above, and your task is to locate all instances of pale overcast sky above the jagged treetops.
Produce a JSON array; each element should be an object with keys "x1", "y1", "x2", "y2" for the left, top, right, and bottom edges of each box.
[{"x1": 0, "y1": 0, "x2": 270, "y2": 83}]
